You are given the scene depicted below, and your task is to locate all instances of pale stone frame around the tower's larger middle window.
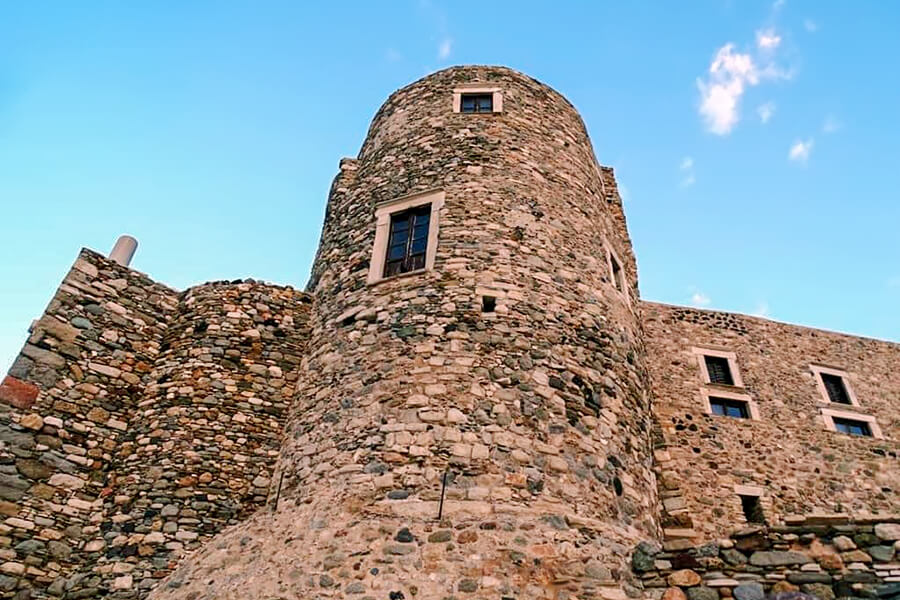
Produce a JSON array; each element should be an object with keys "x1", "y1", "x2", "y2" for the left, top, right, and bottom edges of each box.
[{"x1": 366, "y1": 190, "x2": 445, "y2": 285}]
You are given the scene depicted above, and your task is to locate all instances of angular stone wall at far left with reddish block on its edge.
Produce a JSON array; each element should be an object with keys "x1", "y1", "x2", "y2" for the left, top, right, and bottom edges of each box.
[{"x1": 0, "y1": 250, "x2": 177, "y2": 596}]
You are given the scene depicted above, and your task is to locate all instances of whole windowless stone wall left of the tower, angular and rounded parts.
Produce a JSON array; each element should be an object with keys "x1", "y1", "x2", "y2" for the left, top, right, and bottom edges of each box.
[{"x1": 0, "y1": 250, "x2": 309, "y2": 598}]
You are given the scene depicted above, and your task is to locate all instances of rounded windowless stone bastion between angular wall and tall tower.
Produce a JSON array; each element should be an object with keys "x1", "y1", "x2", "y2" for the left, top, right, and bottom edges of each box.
[{"x1": 89, "y1": 280, "x2": 309, "y2": 597}]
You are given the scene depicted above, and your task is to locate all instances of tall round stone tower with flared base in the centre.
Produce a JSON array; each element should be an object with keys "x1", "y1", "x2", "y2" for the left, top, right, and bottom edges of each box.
[{"x1": 155, "y1": 67, "x2": 657, "y2": 600}]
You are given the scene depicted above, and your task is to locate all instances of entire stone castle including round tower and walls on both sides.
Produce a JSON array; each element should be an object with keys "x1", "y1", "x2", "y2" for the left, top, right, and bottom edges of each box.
[{"x1": 0, "y1": 67, "x2": 900, "y2": 600}]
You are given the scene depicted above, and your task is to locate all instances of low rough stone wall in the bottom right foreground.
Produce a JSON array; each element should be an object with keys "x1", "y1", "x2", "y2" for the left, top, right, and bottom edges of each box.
[{"x1": 632, "y1": 515, "x2": 900, "y2": 600}]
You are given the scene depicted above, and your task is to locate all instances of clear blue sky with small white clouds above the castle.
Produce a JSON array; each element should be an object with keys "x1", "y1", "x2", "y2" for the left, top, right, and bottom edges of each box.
[{"x1": 0, "y1": 0, "x2": 900, "y2": 372}]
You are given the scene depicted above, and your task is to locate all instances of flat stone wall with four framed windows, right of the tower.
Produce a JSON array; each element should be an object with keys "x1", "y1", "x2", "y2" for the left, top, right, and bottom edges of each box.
[{"x1": 642, "y1": 302, "x2": 900, "y2": 547}]
